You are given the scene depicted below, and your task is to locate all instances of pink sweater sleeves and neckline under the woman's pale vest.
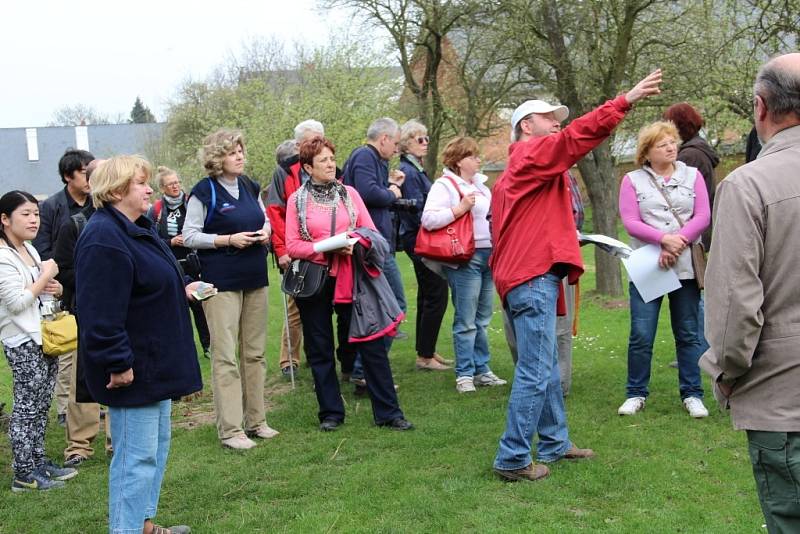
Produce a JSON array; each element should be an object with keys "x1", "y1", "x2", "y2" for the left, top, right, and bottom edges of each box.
[{"x1": 619, "y1": 171, "x2": 711, "y2": 245}]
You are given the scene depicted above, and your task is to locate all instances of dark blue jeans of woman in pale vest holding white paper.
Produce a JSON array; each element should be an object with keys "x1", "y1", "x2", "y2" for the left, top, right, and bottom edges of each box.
[{"x1": 626, "y1": 280, "x2": 703, "y2": 399}]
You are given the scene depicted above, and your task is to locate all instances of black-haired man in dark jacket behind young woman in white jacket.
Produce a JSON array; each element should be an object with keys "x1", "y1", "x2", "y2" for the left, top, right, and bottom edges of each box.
[{"x1": 33, "y1": 149, "x2": 94, "y2": 426}]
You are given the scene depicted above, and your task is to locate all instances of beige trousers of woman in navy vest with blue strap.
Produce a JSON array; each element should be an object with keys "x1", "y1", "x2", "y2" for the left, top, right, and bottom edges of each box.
[{"x1": 203, "y1": 287, "x2": 267, "y2": 439}]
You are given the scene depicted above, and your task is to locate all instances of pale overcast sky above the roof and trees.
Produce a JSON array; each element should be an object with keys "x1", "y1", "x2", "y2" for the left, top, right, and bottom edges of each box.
[{"x1": 0, "y1": 0, "x2": 378, "y2": 128}]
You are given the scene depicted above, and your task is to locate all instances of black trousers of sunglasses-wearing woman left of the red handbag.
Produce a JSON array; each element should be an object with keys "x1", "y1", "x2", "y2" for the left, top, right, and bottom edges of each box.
[{"x1": 406, "y1": 250, "x2": 448, "y2": 358}]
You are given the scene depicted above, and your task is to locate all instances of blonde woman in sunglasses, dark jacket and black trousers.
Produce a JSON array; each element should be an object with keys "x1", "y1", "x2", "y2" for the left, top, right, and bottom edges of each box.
[{"x1": 398, "y1": 120, "x2": 452, "y2": 371}]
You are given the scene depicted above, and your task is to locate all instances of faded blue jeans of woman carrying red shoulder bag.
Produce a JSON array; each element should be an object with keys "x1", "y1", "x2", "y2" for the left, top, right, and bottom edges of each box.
[{"x1": 445, "y1": 248, "x2": 494, "y2": 377}]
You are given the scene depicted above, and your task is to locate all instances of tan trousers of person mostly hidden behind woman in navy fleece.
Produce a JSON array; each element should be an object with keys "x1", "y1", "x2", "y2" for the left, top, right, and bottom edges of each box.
[{"x1": 64, "y1": 351, "x2": 111, "y2": 459}]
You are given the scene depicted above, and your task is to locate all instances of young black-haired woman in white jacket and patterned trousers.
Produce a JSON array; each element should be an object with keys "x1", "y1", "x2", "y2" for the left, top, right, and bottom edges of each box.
[{"x1": 0, "y1": 191, "x2": 78, "y2": 492}]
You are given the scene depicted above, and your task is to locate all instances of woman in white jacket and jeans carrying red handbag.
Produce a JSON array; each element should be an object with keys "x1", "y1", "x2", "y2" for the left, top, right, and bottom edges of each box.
[{"x1": 422, "y1": 137, "x2": 506, "y2": 393}]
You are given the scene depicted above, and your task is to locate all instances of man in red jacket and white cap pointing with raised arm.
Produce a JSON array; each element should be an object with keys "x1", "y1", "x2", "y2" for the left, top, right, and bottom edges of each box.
[{"x1": 490, "y1": 70, "x2": 661, "y2": 480}]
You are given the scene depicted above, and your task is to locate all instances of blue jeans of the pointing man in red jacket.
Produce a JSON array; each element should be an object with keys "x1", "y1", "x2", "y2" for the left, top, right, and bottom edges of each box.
[{"x1": 494, "y1": 273, "x2": 572, "y2": 470}]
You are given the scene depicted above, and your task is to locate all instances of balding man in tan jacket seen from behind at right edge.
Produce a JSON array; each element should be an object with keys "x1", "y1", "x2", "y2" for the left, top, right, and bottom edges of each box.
[{"x1": 700, "y1": 53, "x2": 800, "y2": 533}]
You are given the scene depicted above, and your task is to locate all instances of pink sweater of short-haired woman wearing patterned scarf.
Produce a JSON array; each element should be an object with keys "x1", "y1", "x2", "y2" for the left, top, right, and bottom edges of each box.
[{"x1": 286, "y1": 185, "x2": 376, "y2": 302}]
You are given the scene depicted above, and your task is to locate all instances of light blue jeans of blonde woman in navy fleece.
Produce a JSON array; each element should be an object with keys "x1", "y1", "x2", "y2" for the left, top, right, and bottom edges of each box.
[{"x1": 108, "y1": 400, "x2": 172, "y2": 534}]
